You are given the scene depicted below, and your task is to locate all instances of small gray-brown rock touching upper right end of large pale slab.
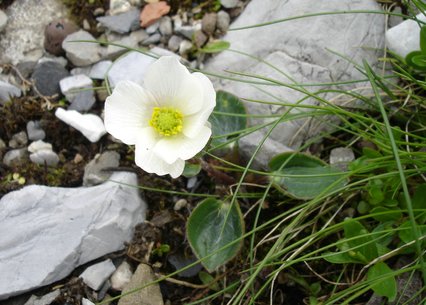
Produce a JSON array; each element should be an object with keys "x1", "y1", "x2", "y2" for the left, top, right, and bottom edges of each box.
[{"x1": 83, "y1": 151, "x2": 120, "y2": 186}]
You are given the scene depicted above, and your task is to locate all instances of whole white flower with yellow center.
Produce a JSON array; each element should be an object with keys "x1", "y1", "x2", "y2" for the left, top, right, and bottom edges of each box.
[{"x1": 105, "y1": 56, "x2": 216, "y2": 178}]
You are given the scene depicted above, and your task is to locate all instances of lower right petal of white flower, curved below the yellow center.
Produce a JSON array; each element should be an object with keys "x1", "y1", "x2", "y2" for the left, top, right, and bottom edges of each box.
[{"x1": 154, "y1": 126, "x2": 212, "y2": 164}]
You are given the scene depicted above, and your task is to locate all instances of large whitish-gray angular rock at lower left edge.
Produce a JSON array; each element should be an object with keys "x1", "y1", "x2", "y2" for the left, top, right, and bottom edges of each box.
[{"x1": 0, "y1": 172, "x2": 146, "y2": 299}]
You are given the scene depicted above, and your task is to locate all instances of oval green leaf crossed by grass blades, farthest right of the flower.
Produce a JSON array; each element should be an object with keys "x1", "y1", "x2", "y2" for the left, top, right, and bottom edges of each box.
[{"x1": 269, "y1": 152, "x2": 346, "y2": 200}]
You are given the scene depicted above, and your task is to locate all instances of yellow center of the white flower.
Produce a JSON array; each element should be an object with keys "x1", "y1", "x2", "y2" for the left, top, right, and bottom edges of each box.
[{"x1": 149, "y1": 107, "x2": 182, "y2": 137}]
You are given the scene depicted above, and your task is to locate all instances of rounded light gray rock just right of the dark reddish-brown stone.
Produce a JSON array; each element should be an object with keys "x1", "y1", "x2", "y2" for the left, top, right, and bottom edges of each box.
[{"x1": 62, "y1": 30, "x2": 101, "y2": 67}]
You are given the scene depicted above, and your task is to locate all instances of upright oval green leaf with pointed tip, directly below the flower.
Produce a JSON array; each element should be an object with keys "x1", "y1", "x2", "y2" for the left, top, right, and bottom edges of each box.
[{"x1": 186, "y1": 198, "x2": 244, "y2": 272}]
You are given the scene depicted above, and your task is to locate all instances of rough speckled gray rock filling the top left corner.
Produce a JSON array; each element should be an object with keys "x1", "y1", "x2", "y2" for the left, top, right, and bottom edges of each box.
[{"x1": 0, "y1": 0, "x2": 67, "y2": 65}]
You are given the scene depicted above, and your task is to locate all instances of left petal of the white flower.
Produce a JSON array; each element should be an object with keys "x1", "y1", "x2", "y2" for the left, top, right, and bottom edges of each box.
[{"x1": 104, "y1": 81, "x2": 154, "y2": 145}]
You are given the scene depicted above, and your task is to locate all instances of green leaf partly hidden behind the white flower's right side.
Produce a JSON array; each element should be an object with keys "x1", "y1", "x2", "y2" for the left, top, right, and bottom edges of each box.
[{"x1": 209, "y1": 90, "x2": 247, "y2": 147}]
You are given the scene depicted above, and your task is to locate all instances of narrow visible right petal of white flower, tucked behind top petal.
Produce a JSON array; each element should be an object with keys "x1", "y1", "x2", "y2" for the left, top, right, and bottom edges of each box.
[{"x1": 182, "y1": 72, "x2": 216, "y2": 138}]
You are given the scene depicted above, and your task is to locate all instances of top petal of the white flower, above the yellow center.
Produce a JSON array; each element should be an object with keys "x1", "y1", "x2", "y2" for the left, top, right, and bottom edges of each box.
[{"x1": 144, "y1": 56, "x2": 203, "y2": 115}]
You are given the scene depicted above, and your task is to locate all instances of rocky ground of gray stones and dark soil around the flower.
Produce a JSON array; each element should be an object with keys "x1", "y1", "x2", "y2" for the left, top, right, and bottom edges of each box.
[{"x1": 0, "y1": 0, "x2": 418, "y2": 305}]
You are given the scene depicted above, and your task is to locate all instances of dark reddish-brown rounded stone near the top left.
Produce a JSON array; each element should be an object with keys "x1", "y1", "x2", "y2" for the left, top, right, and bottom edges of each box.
[{"x1": 44, "y1": 19, "x2": 78, "y2": 56}]
